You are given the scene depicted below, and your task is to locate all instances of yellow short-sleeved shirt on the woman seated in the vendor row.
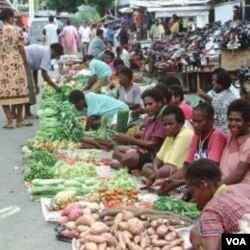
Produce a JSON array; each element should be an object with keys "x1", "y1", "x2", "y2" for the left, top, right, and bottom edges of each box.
[{"x1": 157, "y1": 127, "x2": 194, "y2": 168}]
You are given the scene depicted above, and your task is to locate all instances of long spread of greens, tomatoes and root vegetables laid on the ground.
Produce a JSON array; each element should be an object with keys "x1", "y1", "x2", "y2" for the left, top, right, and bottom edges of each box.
[{"x1": 23, "y1": 78, "x2": 198, "y2": 250}]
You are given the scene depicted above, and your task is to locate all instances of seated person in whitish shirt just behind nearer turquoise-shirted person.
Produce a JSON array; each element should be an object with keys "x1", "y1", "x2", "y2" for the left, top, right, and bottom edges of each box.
[{"x1": 118, "y1": 67, "x2": 141, "y2": 110}]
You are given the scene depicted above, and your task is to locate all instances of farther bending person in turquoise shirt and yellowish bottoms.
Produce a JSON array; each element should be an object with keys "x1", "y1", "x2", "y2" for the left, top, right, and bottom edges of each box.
[{"x1": 82, "y1": 55, "x2": 112, "y2": 92}]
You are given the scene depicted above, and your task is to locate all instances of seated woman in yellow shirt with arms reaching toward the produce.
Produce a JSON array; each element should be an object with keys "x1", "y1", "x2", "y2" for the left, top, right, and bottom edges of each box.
[{"x1": 143, "y1": 106, "x2": 193, "y2": 185}]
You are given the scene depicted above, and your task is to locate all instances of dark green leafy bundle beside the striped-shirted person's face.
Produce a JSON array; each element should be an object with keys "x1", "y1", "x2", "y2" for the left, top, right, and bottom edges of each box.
[{"x1": 153, "y1": 196, "x2": 199, "y2": 219}]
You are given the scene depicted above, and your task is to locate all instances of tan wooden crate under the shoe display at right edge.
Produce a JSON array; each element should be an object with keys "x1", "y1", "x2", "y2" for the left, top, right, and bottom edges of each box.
[{"x1": 220, "y1": 49, "x2": 250, "y2": 71}]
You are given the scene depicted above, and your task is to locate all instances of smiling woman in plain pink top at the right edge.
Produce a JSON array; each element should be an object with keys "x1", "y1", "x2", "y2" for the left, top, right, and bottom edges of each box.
[{"x1": 220, "y1": 99, "x2": 250, "y2": 193}]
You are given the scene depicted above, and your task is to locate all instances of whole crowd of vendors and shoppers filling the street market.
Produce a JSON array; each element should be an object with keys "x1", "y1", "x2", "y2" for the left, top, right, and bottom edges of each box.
[{"x1": 0, "y1": 6, "x2": 250, "y2": 249}]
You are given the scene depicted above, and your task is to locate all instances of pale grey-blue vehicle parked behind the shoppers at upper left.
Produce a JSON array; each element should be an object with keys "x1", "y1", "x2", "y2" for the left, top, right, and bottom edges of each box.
[{"x1": 28, "y1": 17, "x2": 64, "y2": 44}]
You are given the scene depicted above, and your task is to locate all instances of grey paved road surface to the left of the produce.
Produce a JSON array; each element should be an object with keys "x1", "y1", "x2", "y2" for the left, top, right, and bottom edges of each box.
[{"x1": 0, "y1": 70, "x2": 71, "y2": 250}]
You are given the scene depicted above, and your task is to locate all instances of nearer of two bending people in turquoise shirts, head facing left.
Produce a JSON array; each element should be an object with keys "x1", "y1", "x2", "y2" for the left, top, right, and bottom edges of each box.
[{"x1": 69, "y1": 90, "x2": 129, "y2": 122}]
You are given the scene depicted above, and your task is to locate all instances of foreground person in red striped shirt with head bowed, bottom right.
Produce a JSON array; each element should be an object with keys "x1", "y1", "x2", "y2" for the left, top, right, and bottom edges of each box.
[{"x1": 185, "y1": 159, "x2": 250, "y2": 250}]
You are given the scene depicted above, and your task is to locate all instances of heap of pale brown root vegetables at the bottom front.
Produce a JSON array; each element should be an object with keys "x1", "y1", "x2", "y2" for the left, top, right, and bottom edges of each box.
[{"x1": 74, "y1": 210, "x2": 184, "y2": 250}]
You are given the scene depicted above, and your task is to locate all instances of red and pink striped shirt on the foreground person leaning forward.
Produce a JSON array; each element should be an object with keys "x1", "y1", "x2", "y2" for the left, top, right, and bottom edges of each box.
[{"x1": 199, "y1": 186, "x2": 250, "y2": 237}]
